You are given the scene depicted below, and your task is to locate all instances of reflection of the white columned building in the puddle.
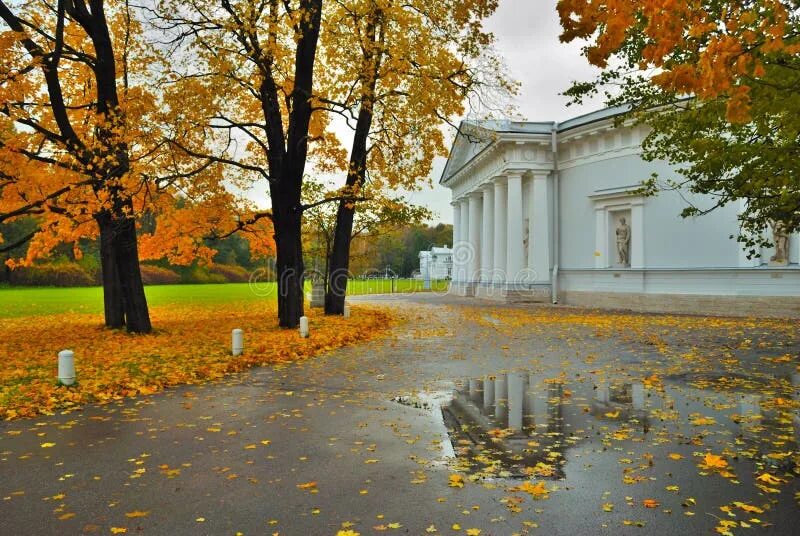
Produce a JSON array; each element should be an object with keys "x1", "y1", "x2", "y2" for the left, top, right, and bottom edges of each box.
[{"x1": 442, "y1": 372, "x2": 800, "y2": 478}]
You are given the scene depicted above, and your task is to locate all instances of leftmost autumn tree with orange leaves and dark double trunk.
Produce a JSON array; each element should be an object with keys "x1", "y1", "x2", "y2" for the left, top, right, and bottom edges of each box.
[{"x1": 0, "y1": 0, "x2": 252, "y2": 332}]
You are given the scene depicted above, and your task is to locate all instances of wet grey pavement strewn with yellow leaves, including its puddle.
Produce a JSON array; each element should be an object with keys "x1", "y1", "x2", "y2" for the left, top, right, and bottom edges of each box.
[{"x1": 0, "y1": 295, "x2": 800, "y2": 535}]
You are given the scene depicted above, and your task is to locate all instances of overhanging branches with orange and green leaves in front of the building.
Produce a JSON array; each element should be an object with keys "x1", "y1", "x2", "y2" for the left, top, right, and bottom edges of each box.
[{"x1": 558, "y1": 0, "x2": 800, "y2": 255}]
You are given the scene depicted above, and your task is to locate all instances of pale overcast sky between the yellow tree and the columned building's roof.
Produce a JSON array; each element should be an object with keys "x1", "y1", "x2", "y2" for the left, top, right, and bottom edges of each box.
[{"x1": 409, "y1": 0, "x2": 602, "y2": 223}]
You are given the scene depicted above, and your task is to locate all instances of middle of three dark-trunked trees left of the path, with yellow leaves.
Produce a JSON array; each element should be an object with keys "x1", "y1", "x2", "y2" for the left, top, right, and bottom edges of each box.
[{"x1": 157, "y1": 0, "x2": 324, "y2": 328}]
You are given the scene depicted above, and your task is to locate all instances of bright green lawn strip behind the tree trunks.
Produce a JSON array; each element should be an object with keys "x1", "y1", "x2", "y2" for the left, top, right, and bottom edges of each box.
[{"x1": 0, "y1": 279, "x2": 448, "y2": 318}]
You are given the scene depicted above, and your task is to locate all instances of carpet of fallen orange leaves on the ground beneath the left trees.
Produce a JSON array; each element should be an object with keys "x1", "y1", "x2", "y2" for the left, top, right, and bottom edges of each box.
[{"x1": 0, "y1": 301, "x2": 395, "y2": 419}]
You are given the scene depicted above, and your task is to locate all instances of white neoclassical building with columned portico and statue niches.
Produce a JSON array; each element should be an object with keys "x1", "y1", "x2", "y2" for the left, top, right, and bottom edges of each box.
[{"x1": 440, "y1": 108, "x2": 800, "y2": 316}]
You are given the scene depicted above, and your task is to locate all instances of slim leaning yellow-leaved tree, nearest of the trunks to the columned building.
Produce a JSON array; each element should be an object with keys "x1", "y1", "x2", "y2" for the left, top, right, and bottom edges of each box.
[{"x1": 320, "y1": 0, "x2": 515, "y2": 314}]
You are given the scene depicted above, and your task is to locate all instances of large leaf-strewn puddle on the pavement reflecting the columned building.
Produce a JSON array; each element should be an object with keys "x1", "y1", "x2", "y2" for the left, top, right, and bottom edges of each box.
[{"x1": 395, "y1": 371, "x2": 800, "y2": 519}]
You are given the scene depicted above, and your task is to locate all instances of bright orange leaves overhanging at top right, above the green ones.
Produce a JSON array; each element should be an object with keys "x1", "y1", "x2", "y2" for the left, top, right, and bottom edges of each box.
[{"x1": 558, "y1": 0, "x2": 800, "y2": 122}]
